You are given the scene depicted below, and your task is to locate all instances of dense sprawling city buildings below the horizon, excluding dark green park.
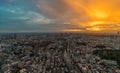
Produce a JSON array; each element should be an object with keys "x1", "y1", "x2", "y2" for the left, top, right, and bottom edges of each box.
[{"x1": 0, "y1": 33, "x2": 120, "y2": 73}]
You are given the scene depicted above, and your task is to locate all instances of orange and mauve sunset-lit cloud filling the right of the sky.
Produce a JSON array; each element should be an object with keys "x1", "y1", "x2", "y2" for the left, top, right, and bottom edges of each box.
[{"x1": 38, "y1": 0, "x2": 120, "y2": 31}]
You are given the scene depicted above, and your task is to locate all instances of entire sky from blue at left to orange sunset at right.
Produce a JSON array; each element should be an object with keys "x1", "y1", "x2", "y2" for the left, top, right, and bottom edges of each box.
[{"x1": 0, "y1": 0, "x2": 120, "y2": 33}]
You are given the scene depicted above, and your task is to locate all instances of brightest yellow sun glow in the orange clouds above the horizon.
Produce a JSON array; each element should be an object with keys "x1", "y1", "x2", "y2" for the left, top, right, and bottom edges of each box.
[{"x1": 87, "y1": 7, "x2": 110, "y2": 32}]
